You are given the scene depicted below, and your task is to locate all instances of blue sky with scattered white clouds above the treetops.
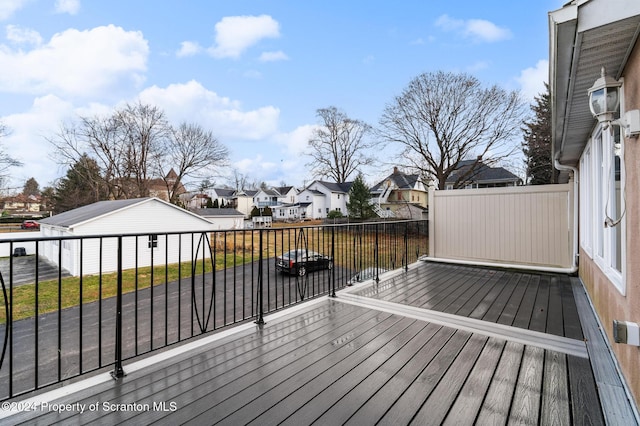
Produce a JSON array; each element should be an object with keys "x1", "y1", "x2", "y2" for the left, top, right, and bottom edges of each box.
[{"x1": 0, "y1": 0, "x2": 563, "y2": 188}]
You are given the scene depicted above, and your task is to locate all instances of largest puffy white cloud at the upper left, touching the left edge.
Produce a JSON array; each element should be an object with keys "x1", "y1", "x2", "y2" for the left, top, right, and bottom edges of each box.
[{"x1": 0, "y1": 25, "x2": 149, "y2": 97}]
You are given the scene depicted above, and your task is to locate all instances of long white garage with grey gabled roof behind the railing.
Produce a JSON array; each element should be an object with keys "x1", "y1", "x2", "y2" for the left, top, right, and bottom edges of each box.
[{"x1": 39, "y1": 198, "x2": 213, "y2": 276}]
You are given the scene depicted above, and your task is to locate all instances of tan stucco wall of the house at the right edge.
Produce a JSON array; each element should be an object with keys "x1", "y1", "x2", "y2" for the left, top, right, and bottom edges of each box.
[{"x1": 579, "y1": 43, "x2": 640, "y2": 404}]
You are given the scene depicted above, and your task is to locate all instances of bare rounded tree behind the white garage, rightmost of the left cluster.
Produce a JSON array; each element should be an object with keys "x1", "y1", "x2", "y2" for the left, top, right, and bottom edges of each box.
[{"x1": 156, "y1": 123, "x2": 229, "y2": 203}]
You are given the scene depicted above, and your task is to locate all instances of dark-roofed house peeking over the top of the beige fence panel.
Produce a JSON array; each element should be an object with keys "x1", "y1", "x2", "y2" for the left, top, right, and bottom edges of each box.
[{"x1": 445, "y1": 159, "x2": 522, "y2": 189}]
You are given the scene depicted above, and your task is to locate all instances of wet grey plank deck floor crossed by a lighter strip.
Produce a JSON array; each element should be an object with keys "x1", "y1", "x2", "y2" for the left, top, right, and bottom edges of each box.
[{"x1": 0, "y1": 262, "x2": 636, "y2": 425}]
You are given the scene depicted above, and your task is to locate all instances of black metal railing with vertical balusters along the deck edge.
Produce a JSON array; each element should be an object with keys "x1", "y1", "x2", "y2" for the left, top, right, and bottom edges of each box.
[{"x1": 0, "y1": 221, "x2": 428, "y2": 400}]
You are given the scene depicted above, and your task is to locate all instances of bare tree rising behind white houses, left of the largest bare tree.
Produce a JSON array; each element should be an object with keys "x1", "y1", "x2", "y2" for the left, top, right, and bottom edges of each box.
[{"x1": 307, "y1": 106, "x2": 375, "y2": 182}]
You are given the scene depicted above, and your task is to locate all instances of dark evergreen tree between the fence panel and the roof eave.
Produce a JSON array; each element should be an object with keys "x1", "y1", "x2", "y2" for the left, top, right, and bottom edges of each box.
[{"x1": 522, "y1": 84, "x2": 553, "y2": 185}]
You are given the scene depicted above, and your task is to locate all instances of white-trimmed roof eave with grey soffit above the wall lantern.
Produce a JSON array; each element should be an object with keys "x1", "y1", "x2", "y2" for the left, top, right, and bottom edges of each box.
[{"x1": 549, "y1": 0, "x2": 640, "y2": 175}]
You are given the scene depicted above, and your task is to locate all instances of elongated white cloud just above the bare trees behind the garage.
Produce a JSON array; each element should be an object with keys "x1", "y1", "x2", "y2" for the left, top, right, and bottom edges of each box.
[{"x1": 139, "y1": 81, "x2": 280, "y2": 143}]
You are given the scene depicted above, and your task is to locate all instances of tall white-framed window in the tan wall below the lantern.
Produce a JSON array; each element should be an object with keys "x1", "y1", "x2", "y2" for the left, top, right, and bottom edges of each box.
[{"x1": 580, "y1": 126, "x2": 626, "y2": 294}]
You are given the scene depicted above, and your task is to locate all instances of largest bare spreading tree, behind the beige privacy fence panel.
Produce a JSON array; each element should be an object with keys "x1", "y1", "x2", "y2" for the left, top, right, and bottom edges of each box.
[{"x1": 379, "y1": 71, "x2": 526, "y2": 189}]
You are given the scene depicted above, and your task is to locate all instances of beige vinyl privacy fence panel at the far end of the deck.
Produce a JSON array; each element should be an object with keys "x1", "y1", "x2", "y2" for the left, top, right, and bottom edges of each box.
[{"x1": 429, "y1": 183, "x2": 573, "y2": 268}]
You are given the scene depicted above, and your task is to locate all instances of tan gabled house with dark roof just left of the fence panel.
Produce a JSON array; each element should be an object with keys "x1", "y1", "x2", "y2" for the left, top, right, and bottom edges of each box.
[{"x1": 370, "y1": 167, "x2": 429, "y2": 219}]
